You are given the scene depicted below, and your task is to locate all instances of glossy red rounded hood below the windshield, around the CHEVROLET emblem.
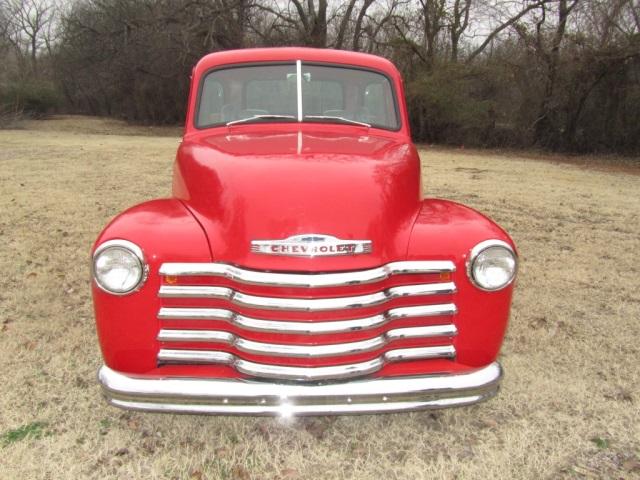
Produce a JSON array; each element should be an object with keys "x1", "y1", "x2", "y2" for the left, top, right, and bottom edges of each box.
[{"x1": 174, "y1": 127, "x2": 420, "y2": 271}]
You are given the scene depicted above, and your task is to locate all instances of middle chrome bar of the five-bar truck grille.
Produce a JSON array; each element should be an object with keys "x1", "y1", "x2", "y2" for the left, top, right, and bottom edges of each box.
[{"x1": 158, "y1": 303, "x2": 457, "y2": 335}]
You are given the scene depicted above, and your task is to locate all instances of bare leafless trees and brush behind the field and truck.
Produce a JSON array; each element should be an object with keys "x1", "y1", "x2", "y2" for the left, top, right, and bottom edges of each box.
[{"x1": 0, "y1": 0, "x2": 640, "y2": 155}]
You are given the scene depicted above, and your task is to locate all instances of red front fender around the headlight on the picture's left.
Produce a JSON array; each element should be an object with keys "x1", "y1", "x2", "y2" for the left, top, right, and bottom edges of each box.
[{"x1": 91, "y1": 199, "x2": 211, "y2": 373}]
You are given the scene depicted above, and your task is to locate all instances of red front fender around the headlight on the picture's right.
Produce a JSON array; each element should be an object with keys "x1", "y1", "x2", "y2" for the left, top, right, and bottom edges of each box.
[{"x1": 407, "y1": 199, "x2": 516, "y2": 367}]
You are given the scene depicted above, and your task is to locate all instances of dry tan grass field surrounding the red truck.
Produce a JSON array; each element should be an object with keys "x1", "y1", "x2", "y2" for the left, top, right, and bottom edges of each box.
[{"x1": 0, "y1": 118, "x2": 640, "y2": 480}]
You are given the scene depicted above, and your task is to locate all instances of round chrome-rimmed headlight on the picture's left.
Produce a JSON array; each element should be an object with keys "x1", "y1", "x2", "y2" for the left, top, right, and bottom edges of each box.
[{"x1": 93, "y1": 240, "x2": 147, "y2": 295}]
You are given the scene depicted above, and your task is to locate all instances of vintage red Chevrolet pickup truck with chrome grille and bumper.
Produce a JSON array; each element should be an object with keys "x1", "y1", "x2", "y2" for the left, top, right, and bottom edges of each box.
[{"x1": 92, "y1": 48, "x2": 517, "y2": 416}]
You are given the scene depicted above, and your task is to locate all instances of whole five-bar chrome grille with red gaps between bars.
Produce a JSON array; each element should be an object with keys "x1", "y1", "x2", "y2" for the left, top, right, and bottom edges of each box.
[{"x1": 157, "y1": 260, "x2": 457, "y2": 381}]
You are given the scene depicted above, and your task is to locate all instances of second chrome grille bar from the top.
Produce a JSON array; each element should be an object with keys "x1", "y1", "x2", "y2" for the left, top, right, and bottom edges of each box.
[{"x1": 158, "y1": 282, "x2": 456, "y2": 312}]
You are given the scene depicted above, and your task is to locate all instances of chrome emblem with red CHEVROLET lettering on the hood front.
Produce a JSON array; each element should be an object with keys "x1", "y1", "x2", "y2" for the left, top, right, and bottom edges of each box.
[{"x1": 251, "y1": 233, "x2": 371, "y2": 257}]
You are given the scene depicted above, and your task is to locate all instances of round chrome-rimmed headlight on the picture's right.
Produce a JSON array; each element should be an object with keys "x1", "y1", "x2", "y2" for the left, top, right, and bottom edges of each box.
[{"x1": 467, "y1": 240, "x2": 518, "y2": 291}]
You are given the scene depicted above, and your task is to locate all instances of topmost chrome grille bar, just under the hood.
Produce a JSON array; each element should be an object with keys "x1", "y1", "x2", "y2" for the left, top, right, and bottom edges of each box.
[{"x1": 160, "y1": 260, "x2": 456, "y2": 288}]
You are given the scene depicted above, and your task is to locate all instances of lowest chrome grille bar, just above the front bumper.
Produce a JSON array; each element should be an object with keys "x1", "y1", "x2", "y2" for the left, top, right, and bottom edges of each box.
[{"x1": 158, "y1": 345, "x2": 455, "y2": 381}]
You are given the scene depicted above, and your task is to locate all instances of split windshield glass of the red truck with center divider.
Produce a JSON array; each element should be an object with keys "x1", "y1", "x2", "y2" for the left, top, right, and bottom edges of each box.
[{"x1": 196, "y1": 62, "x2": 399, "y2": 130}]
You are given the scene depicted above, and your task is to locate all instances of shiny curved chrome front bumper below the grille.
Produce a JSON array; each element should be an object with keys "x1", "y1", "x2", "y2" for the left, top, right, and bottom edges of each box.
[{"x1": 98, "y1": 362, "x2": 502, "y2": 417}]
